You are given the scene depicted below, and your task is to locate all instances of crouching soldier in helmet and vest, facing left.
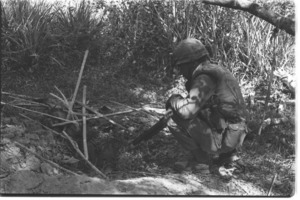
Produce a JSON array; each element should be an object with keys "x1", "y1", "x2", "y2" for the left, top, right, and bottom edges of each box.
[{"x1": 166, "y1": 38, "x2": 248, "y2": 173}]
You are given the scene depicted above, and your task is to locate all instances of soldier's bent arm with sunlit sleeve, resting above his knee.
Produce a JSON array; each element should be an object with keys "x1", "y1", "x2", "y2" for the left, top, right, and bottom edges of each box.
[{"x1": 172, "y1": 75, "x2": 216, "y2": 119}]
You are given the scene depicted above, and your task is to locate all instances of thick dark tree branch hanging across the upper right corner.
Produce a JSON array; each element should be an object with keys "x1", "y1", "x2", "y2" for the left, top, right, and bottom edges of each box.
[{"x1": 203, "y1": 0, "x2": 295, "y2": 36}]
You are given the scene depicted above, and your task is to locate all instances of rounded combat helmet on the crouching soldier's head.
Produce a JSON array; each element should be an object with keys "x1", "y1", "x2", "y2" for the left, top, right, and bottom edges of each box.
[{"x1": 173, "y1": 38, "x2": 209, "y2": 65}]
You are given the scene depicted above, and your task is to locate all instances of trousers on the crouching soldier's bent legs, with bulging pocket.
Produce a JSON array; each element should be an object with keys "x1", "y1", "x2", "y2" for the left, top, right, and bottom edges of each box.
[{"x1": 168, "y1": 115, "x2": 247, "y2": 162}]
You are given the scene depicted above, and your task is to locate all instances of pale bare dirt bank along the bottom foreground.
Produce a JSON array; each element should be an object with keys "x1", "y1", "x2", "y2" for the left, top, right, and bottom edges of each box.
[{"x1": 0, "y1": 106, "x2": 293, "y2": 196}]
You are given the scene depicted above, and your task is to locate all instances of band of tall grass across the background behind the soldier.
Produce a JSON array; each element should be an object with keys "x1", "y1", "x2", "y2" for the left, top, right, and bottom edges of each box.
[{"x1": 2, "y1": 0, "x2": 295, "y2": 88}]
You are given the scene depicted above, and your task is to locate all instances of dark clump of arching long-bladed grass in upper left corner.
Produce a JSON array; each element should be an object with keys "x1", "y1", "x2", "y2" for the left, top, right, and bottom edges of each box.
[{"x1": 1, "y1": 0, "x2": 101, "y2": 72}]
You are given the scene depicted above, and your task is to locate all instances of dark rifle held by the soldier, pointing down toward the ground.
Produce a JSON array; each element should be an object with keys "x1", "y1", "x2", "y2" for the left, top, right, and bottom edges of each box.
[{"x1": 132, "y1": 109, "x2": 173, "y2": 145}]
